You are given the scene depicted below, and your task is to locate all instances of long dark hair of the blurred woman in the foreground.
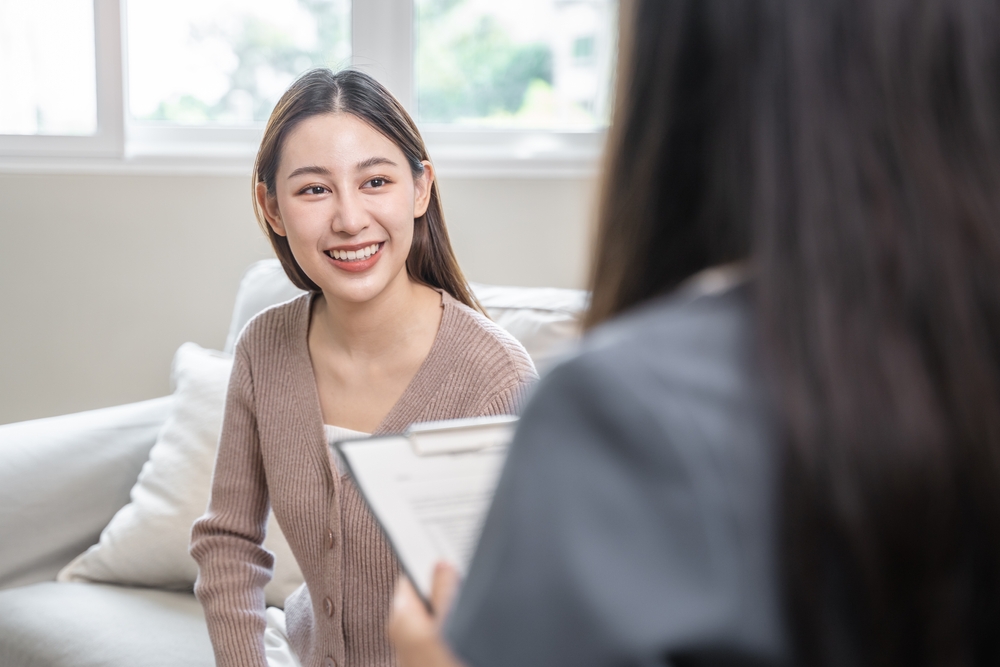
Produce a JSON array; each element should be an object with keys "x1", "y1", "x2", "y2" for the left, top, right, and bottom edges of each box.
[{"x1": 589, "y1": 0, "x2": 1000, "y2": 666}]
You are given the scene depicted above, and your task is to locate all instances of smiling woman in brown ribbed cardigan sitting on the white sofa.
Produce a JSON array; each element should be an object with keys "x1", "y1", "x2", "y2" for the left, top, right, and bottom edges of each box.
[{"x1": 191, "y1": 69, "x2": 536, "y2": 667}]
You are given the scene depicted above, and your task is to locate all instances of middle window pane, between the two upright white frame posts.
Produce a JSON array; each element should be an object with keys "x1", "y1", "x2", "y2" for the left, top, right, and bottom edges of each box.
[{"x1": 126, "y1": 0, "x2": 351, "y2": 127}]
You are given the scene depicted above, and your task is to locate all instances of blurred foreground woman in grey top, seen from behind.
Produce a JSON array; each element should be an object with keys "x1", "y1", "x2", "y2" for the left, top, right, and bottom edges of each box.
[{"x1": 390, "y1": 0, "x2": 1000, "y2": 667}]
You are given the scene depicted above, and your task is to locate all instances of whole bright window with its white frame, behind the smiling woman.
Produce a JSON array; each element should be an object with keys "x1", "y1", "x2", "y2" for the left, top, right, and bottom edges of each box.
[{"x1": 0, "y1": 0, "x2": 617, "y2": 175}]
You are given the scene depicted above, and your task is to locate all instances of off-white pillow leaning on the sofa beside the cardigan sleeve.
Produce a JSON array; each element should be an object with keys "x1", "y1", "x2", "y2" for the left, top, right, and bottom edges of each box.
[{"x1": 57, "y1": 343, "x2": 302, "y2": 607}]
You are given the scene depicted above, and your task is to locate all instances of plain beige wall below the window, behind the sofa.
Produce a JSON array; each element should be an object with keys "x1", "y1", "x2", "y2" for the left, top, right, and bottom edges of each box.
[{"x1": 0, "y1": 173, "x2": 593, "y2": 424}]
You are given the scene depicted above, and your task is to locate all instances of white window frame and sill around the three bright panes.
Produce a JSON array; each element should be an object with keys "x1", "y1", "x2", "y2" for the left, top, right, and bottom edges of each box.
[{"x1": 0, "y1": 0, "x2": 605, "y2": 178}]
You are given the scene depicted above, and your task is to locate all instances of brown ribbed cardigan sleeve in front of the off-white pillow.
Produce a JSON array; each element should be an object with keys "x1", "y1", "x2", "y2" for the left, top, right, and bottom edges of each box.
[{"x1": 191, "y1": 347, "x2": 274, "y2": 667}]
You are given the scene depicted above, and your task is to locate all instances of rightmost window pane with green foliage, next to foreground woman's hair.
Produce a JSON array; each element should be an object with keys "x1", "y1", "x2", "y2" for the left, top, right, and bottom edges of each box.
[{"x1": 416, "y1": 0, "x2": 615, "y2": 130}]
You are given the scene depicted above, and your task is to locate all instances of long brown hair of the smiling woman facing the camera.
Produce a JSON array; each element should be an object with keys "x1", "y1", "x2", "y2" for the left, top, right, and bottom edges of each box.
[{"x1": 252, "y1": 68, "x2": 483, "y2": 312}]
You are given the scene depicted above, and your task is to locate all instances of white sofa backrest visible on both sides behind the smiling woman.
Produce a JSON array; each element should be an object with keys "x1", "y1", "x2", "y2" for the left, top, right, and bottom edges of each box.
[{"x1": 225, "y1": 259, "x2": 588, "y2": 371}]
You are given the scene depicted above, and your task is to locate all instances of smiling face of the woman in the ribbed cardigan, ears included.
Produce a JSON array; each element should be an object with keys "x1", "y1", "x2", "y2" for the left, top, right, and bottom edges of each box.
[{"x1": 257, "y1": 113, "x2": 433, "y2": 303}]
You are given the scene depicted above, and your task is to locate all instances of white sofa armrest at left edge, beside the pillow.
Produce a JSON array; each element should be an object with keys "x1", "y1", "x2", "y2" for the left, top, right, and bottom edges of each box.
[{"x1": 0, "y1": 396, "x2": 173, "y2": 589}]
